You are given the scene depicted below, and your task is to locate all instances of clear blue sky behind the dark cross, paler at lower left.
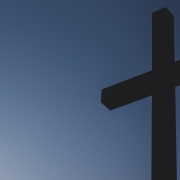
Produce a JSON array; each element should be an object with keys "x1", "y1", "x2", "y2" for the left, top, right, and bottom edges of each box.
[{"x1": 0, "y1": 0, "x2": 180, "y2": 180}]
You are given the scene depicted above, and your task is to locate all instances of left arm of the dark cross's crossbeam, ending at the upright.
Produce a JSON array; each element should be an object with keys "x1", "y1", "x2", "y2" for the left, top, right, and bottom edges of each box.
[{"x1": 101, "y1": 71, "x2": 152, "y2": 110}]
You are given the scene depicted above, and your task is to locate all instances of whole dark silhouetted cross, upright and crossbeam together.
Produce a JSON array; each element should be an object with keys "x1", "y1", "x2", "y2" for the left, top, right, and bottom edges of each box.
[{"x1": 101, "y1": 8, "x2": 180, "y2": 180}]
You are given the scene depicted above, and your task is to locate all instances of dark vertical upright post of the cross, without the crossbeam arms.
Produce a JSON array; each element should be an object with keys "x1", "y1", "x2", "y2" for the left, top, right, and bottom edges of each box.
[{"x1": 152, "y1": 9, "x2": 177, "y2": 180}]
